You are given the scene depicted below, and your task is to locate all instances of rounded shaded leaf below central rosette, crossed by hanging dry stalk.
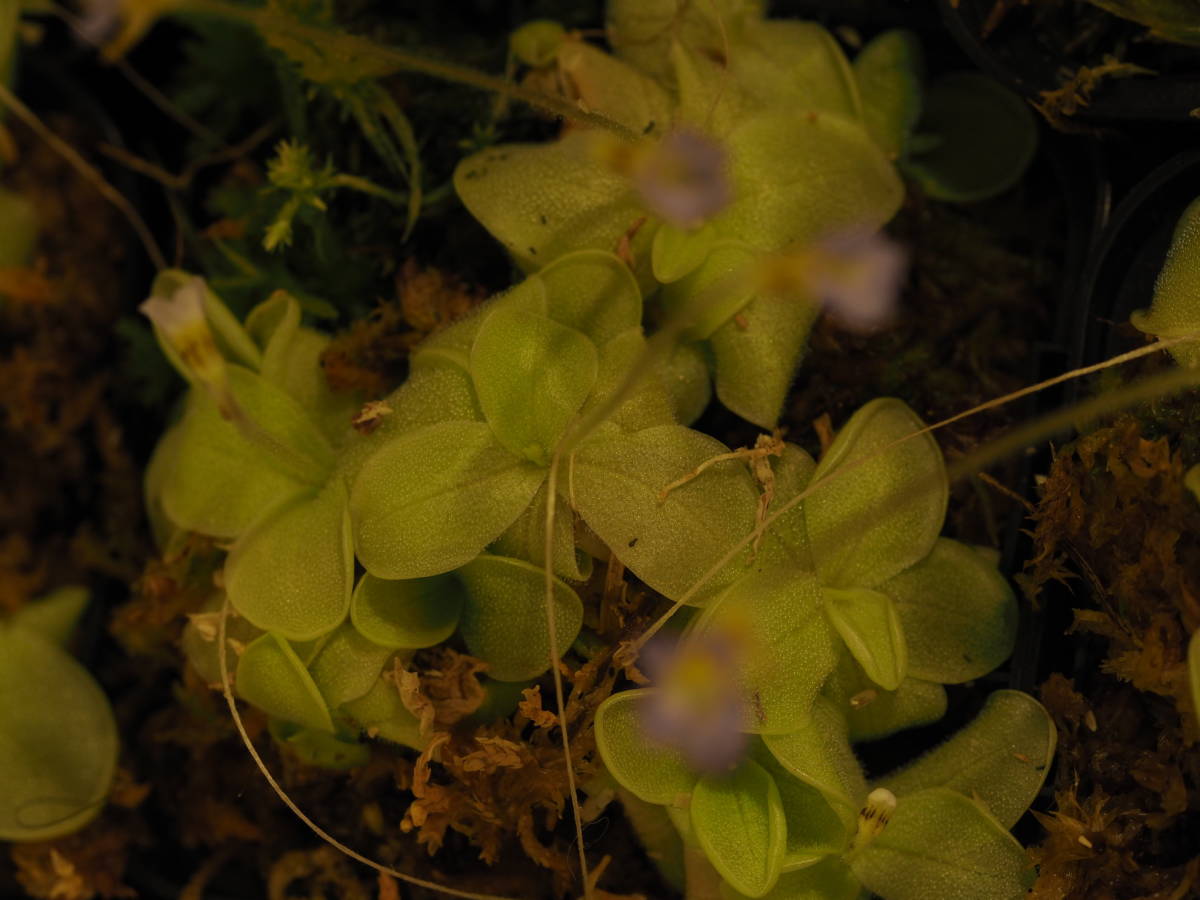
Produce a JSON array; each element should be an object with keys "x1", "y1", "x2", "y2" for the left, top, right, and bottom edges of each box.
[{"x1": 455, "y1": 554, "x2": 583, "y2": 682}]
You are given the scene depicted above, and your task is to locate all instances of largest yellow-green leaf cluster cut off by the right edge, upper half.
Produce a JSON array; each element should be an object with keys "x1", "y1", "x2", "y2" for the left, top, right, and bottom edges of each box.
[{"x1": 1130, "y1": 199, "x2": 1200, "y2": 368}]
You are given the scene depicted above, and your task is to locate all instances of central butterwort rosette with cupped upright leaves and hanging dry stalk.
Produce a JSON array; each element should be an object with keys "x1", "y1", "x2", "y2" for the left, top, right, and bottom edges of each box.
[{"x1": 350, "y1": 251, "x2": 757, "y2": 609}]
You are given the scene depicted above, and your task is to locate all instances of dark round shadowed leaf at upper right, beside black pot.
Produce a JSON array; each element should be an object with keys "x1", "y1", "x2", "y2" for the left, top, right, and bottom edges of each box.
[{"x1": 904, "y1": 72, "x2": 1038, "y2": 203}]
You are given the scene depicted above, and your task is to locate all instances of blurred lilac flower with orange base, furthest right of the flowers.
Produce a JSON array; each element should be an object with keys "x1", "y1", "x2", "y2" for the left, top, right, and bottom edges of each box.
[{"x1": 805, "y1": 228, "x2": 908, "y2": 332}]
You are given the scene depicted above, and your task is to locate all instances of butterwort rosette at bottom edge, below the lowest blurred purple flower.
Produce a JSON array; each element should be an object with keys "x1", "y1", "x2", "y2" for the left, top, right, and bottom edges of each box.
[{"x1": 596, "y1": 690, "x2": 1055, "y2": 900}]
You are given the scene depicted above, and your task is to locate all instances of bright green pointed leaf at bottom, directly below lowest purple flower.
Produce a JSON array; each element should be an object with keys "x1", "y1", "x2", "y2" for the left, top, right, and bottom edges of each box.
[{"x1": 691, "y1": 760, "x2": 787, "y2": 896}]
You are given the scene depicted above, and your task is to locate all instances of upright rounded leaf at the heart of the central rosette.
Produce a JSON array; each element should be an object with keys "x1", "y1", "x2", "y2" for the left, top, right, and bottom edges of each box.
[{"x1": 470, "y1": 308, "x2": 599, "y2": 464}]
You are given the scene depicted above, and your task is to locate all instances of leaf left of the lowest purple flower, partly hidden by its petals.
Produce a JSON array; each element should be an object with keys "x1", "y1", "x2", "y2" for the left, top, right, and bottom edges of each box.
[{"x1": 595, "y1": 689, "x2": 700, "y2": 804}]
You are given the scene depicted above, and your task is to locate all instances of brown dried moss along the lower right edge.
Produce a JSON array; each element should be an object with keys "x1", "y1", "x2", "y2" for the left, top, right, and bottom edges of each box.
[{"x1": 1025, "y1": 415, "x2": 1200, "y2": 900}]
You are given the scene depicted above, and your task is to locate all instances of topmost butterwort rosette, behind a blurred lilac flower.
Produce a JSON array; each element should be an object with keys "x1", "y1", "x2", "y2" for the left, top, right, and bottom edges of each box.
[{"x1": 455, "y1": 0, "x2": 914, "y2": 427}]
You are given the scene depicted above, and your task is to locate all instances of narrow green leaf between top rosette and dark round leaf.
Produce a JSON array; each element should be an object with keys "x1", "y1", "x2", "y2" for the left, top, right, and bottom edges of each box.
[{"x1": 854, "y1": 29, "x2": 924, "y2": 160}]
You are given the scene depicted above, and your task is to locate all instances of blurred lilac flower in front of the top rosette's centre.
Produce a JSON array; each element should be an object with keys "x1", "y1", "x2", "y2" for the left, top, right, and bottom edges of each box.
[{"x1": 631, "y1": 130, "x2": 733, "y2": 228}]
